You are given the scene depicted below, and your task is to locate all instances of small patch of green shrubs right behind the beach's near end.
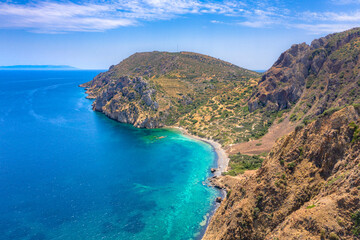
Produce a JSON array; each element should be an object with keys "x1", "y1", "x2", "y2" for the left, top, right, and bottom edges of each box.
[{"x1": 224, "y1": 153, "x2": 263, "y2": 176}]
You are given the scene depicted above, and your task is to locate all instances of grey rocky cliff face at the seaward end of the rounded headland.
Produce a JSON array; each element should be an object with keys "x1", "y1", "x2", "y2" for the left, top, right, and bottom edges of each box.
[{"x1": 93, "y1": 76, "x2": 162, "y2": 128}]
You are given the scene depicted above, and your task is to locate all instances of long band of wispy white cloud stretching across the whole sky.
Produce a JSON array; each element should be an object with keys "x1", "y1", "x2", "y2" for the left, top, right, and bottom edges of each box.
[{"x1": 0, "y1": 0, "x2": 360, "y2": 33}]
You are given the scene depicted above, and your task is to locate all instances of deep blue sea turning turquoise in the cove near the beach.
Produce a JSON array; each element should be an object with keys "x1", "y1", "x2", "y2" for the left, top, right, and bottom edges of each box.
[{"x1": 0, "y1": 71, "x2": 220, "y2": 240}]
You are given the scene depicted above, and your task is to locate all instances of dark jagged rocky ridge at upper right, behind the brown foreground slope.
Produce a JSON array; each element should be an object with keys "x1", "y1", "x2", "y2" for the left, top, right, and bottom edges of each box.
[{"x1": 248, "y1": 28, "x2": 360, "y2": 120}]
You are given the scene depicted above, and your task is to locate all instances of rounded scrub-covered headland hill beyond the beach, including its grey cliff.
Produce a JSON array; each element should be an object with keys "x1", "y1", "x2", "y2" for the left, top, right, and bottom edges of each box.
[{"x1": 81, "y1": 52, "x2": 269, "y2": 144}]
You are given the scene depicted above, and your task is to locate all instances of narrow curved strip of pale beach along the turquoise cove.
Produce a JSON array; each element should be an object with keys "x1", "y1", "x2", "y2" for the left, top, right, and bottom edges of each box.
[{"x1": 168, "y1": 127, "x2": 230, "y2": 176}]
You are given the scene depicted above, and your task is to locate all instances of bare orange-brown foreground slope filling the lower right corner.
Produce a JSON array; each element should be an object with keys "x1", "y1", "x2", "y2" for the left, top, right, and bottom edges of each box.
[{"x1": 204, "y1": 105, "x2": 360, "y2": 240}]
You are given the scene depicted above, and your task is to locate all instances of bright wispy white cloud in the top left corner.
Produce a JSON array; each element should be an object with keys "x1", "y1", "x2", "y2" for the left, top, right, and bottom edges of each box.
[{"x1": 0, "y1": 2, "x2": 135, "y2": 33}]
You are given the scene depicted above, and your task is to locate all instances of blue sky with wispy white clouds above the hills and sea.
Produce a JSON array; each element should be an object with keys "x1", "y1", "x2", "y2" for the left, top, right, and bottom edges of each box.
[{"x1": 0, "y1": 0, "x2": 360, "y2": 70}]
